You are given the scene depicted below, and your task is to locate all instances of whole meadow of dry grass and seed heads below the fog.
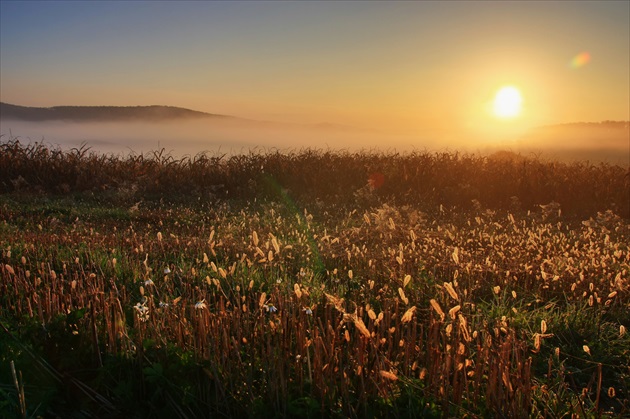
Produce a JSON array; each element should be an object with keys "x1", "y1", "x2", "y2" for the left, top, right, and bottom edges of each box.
[{"x1": 0, "y1": 138, "x2": 630, "y2": 418}]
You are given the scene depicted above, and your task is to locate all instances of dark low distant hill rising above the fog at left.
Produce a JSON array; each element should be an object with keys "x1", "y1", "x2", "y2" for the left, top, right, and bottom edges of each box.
[{"x1": 0, "y1": 102, "x2": 232, "y2": 122}]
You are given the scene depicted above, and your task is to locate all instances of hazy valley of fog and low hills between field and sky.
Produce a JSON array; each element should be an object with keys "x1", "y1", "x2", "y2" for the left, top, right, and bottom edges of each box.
[{"x1": 0, "y1": 103, "x2": 630, "y2": 166}]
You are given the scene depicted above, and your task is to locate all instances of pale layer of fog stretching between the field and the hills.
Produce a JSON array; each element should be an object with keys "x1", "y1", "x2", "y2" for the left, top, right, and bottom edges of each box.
[{"x1": 0, "y1": 119, "x2": 630, "y2": 166}]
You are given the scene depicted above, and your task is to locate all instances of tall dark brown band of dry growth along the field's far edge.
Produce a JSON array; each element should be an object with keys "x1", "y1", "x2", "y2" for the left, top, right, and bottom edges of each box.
[{"x1": 0, "y1": 138, "x2": 630, "y2": 218}]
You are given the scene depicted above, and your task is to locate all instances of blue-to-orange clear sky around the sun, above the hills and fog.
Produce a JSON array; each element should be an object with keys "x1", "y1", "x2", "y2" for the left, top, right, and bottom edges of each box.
[{"x1": 0, "y1": 0, "x2": 630, "y2": 148}]
